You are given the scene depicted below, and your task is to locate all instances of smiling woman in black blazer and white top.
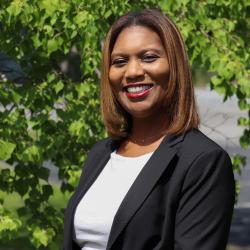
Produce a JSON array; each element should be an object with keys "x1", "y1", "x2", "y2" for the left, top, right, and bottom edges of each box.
[{"x1": 64, "y1": 10, "x2": 234, "y2": 250}]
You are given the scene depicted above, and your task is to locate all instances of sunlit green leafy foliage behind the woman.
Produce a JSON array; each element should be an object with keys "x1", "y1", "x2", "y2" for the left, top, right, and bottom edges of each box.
[{"x1": 0, "y1": 0, "x2": 250, "y2": 249}]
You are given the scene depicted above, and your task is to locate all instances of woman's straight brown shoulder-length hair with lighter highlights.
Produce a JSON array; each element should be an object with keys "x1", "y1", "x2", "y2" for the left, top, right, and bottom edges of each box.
[{"x1": 101, "y1": 9, "x2": 199, "y2": 138}]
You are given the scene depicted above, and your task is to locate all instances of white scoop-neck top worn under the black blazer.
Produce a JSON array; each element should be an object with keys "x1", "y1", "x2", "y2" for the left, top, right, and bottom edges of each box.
[{"x1": 74, "y1": 152, "x2": 153, "y2": 250}]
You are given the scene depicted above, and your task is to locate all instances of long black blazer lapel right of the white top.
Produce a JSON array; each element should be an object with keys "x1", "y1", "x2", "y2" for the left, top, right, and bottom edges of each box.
[{"x1": 107, "y1": 136, "x2": 183, "y2": 250}]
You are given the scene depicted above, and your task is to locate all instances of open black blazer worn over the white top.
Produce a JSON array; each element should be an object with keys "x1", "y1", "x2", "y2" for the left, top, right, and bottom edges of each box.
[{"x1": 63, "y1": 129, "x2": 235, "y2": 250}]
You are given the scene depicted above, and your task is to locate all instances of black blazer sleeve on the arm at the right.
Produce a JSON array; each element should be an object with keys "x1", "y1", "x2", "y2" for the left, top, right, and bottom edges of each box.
[{"x1": 175, "y1": 149, "x2": 235, "y2": 250}]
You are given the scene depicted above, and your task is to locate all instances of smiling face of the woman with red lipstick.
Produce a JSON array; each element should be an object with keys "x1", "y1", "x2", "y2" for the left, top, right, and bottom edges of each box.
[{"x1": 109, "y1": 26, "x2": 169, "y2": 118}]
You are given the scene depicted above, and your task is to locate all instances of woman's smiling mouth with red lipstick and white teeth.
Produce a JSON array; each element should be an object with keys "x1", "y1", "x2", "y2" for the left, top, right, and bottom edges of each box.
[{"x1": 124, "y1": 84, "x2": 153, "y2": 98}]
